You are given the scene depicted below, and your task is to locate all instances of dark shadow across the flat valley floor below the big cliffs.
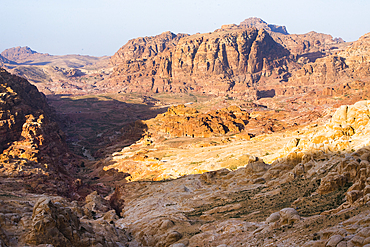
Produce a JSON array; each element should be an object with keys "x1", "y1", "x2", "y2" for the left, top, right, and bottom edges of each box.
[{"x1": 48, "y1": 95, "x2": 167, "y2": 157}]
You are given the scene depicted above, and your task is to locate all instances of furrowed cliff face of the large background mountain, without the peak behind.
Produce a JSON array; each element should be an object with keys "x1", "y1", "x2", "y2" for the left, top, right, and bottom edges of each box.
[{"x1": 102, "y1": 28, "x2": 289, "y2": 94}]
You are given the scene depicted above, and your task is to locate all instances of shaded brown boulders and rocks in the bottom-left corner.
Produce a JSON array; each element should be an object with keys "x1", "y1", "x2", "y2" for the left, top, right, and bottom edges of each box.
[{"x1": 0, "y1": 193, "x2": 129, "y2": 247}]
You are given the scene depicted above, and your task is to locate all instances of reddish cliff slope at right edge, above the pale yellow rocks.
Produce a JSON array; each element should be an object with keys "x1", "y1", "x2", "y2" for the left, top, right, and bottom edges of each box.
[{"x1": 275, "y1": 34, "x2": 370, "y2": 100}]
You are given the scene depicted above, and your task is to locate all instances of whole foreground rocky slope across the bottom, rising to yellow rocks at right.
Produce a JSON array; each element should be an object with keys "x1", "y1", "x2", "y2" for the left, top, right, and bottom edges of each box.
[{"x1": 0, "y1": 101, "x2": 370, "y2": 247}]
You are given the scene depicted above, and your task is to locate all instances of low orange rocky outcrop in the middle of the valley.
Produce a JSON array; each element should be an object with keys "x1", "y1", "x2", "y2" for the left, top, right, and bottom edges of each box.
[{"x1": 145, "y1": 105, "x2": 298, "y2": 140}]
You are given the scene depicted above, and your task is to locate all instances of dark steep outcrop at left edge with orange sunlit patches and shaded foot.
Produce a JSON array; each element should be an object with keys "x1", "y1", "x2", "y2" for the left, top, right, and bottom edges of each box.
[{"x1": 0, "y1": 70, "x2": 78, "y2": 196}]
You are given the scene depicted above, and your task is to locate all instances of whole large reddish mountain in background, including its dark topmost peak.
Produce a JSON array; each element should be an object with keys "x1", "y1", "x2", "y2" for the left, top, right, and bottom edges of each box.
[{"x1": 102, "y1": 18, "x2": 347, "y2": 102}]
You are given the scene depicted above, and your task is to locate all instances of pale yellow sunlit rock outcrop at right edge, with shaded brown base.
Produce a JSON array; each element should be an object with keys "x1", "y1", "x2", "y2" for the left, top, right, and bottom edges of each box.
[{"x1": 264, "y1": 101, "x2": 370, "y2": 208}]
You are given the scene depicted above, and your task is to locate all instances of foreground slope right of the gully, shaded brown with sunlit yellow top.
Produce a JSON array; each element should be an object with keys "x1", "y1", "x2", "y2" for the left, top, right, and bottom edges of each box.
[{"x1": 96, "y1": 101, "x2": 370, "y2": 246}]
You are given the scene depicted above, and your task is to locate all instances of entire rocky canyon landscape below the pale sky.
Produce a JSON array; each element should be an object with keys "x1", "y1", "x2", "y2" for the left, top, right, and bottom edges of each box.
[{"x1": 0, "y1": 17, "x2": 370, "y2": 247}]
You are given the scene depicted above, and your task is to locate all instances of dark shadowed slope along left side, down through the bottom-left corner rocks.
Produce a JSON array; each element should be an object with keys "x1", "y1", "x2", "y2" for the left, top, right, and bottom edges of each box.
[{"x1": 0, "y1": 69, "x2": 129, "y2": 247}]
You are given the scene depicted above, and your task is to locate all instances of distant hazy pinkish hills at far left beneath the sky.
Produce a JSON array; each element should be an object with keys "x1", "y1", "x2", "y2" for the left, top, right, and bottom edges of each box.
[{"x1": 0, "y1": 46, "x2": 111, "y2": 95}]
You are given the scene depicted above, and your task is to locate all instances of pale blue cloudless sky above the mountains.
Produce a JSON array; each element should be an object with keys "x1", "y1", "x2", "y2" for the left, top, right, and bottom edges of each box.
[{"x1": 0, "y1": 0, "x2": 370, "y2": 56}]
